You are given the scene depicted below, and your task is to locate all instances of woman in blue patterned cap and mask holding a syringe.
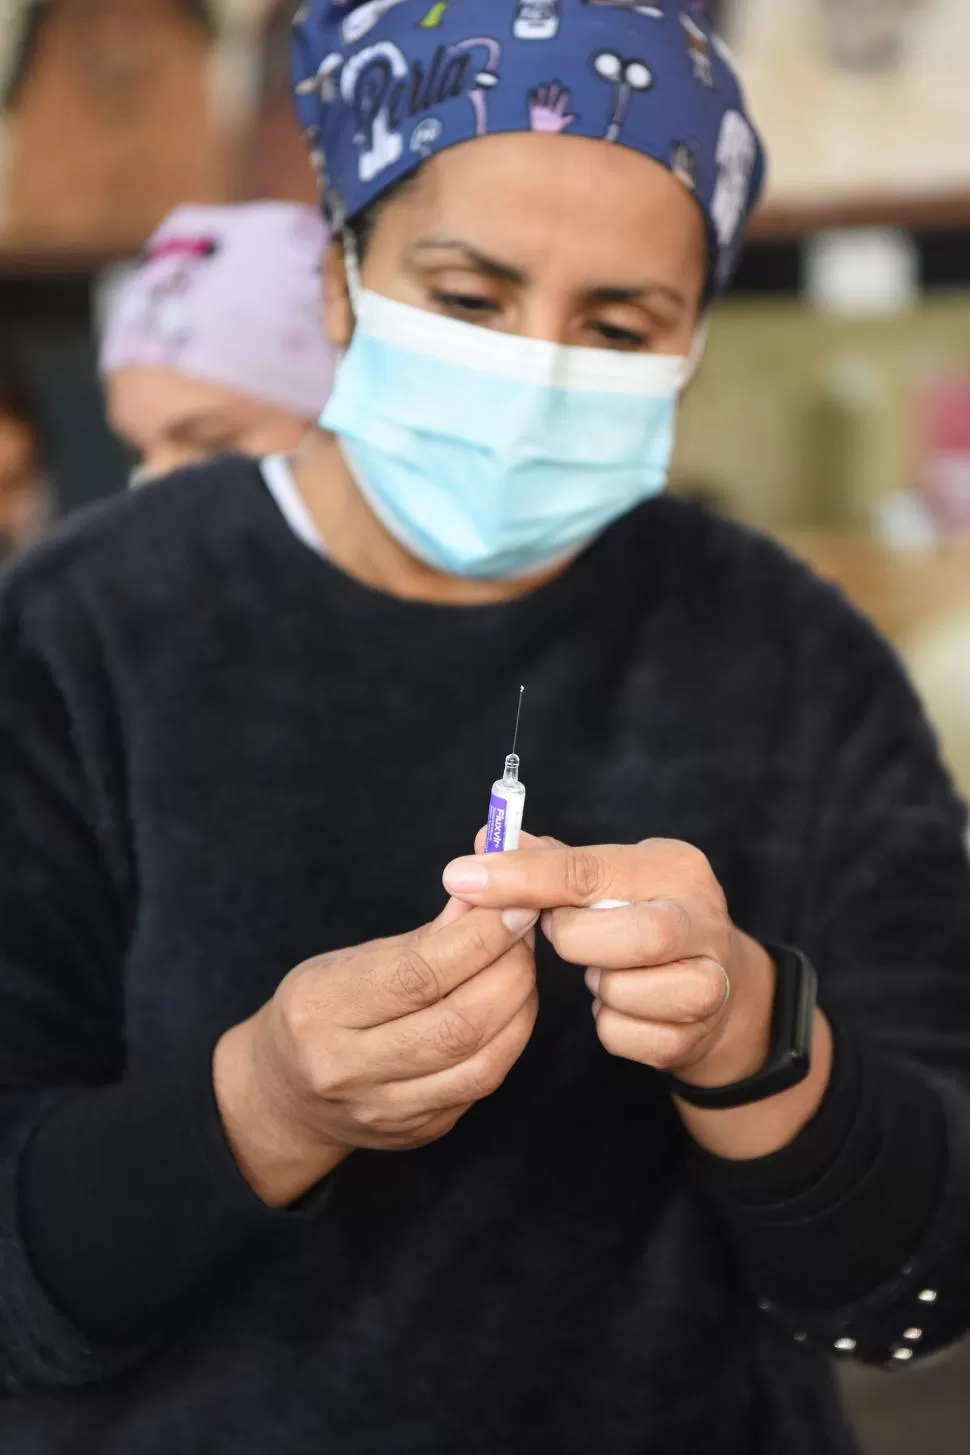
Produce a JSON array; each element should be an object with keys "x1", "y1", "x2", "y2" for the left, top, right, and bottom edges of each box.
[{"x1": 0, "y1": 0, "x2": 970, "y2": 1455}]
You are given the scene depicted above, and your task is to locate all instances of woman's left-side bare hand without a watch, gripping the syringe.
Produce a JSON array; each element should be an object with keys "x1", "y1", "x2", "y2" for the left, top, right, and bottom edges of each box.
[{"x1": 212, "y1": 904, "x2": 537, "y2": 1206}]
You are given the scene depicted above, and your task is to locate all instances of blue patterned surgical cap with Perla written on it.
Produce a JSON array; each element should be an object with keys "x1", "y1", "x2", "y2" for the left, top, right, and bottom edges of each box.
[{"x1": 294, "y1": 0, "x2": 765, "y2": 288}]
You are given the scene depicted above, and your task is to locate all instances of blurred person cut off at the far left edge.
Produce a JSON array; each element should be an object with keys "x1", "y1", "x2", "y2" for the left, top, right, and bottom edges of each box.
[{"x1": 0, "y1": 354, "x2": 51, "y2": 560}]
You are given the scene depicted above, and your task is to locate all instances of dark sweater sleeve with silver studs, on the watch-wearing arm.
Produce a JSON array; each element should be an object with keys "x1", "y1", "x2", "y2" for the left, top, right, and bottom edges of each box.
[{"x1": 705, "y1": 576, "x2": 970, "y2": 1368}]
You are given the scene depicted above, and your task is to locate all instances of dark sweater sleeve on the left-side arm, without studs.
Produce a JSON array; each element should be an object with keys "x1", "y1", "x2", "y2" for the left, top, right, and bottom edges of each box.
[{"x1": 0, "y1": 573, "x2": 311, "y2": 1392}]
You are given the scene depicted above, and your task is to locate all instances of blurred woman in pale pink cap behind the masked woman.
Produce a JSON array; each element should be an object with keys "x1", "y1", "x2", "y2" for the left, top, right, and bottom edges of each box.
[{"x1": 100, "y1": 202, "x2": 334, "y2": 480}]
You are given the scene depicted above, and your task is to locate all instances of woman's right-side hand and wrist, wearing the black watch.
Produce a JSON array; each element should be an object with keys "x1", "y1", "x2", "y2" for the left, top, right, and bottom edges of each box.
[{"x1": 445, "y1": 840, "x2": 832, "y2": 1158}]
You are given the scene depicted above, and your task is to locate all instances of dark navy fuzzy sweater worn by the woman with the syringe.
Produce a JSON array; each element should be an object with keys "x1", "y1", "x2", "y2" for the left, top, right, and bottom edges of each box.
[{"x1": 0, "y1": 460, "x2": 970, "y2": 1455}]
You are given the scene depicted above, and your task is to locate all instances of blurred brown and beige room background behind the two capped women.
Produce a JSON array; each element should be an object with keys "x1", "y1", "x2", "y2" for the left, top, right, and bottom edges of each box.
[{"x1": 0, "y1": 0, "x2": 970, "y2": 1455}]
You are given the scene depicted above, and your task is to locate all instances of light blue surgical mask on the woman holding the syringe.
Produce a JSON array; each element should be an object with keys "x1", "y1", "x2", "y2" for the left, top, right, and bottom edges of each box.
[{"x1": 321, "y1": 273, "x2": 689, "y2": 579}]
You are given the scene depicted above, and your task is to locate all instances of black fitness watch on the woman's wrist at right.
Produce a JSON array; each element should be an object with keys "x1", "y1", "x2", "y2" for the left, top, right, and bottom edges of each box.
[{"x1": 663, "y1": 944, "x2": 819, "y2": 1112}]
